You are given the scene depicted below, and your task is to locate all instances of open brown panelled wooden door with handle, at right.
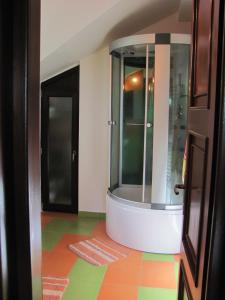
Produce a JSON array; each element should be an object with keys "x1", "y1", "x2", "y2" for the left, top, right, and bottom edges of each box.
[{"x1": 178, "y1": 0, "x2": 222, "y2": 300}]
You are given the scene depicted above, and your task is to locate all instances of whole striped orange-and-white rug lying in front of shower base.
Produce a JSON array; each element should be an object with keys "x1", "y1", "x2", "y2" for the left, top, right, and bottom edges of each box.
[{"x1": 69, "y1": 238, "x2": 130, "y2": 266}]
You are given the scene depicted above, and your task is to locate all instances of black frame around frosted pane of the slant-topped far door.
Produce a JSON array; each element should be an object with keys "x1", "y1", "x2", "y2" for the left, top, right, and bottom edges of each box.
[{"x1": 41, "y1": 66, "x2": 80, "y2": 214}]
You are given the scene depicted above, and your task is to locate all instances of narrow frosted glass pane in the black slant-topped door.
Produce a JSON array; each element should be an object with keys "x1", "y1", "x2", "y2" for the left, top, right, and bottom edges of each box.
[{"x1": 48, "y1": 97, "x2": 72, "y2": 204}]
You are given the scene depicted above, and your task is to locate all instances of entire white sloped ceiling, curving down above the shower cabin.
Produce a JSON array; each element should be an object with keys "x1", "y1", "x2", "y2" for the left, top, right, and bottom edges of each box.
[{"x1": 41, "y1": 0, "x2": 180, "y2": 80}]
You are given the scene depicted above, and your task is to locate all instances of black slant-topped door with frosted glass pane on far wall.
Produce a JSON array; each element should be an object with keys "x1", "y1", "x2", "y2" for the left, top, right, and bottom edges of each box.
[{"x1": 42, "y1": 67, "x2": 79, "y2": 213}]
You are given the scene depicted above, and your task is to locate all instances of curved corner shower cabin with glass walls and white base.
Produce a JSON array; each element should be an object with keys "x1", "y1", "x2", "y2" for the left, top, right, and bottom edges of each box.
[{"x1": 106, "y1": 34, "x2": 190, "y2": 253}]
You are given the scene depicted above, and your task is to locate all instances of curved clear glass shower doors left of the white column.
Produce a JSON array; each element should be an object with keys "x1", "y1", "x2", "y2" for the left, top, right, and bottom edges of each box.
[{"x1": 110, "y1": 45, "x2": 154, "y2": 203}]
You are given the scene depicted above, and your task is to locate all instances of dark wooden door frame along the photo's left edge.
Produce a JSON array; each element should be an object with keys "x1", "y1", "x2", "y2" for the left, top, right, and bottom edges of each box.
[{"x1": 0, "y1": 0, "x2": 42, "y2": 300}]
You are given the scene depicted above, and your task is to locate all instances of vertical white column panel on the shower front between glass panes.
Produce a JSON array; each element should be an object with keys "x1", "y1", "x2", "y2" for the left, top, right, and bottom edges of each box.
[{"x1": 151, "y1": 44, "x2": 170, "y2": 207}]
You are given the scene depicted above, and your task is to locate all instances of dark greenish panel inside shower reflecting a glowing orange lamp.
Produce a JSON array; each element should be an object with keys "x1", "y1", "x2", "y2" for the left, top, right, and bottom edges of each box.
[{"x1": 122, "y1": 55, "x2": 146, "y2": 185}]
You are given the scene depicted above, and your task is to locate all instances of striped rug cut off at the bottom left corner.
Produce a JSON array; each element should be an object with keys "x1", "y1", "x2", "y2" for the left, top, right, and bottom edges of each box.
[{"x1": 42, "y1": 277, "x2": 69, "y2": 300}]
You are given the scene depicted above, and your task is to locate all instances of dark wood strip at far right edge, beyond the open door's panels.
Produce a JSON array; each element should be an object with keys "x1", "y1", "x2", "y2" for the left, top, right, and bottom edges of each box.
[{"x1": 206, "y1": 1, "x2": 225, "y2": 300}]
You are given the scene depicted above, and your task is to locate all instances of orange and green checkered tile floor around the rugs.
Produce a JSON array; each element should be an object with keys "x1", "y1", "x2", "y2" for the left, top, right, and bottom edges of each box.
[{"x1": 42, "y1": 213, "x2": 179, "y2": 300}]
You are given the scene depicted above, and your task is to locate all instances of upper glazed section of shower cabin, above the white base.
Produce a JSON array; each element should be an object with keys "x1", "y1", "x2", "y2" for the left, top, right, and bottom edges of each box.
[{"x1": 110, "y1": 37, "x2": 190, "y2": 209}]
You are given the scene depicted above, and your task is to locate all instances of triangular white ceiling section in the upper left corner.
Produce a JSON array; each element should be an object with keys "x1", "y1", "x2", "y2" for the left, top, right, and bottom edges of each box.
[{"x1": 41, "y1": 0, "x2": 120, "y2": 58}]
